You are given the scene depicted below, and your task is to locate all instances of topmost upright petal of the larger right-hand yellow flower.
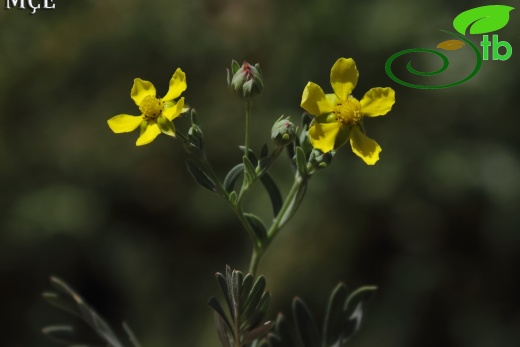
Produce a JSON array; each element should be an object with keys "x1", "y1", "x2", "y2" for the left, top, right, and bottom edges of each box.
[{"x1": 330, "y1": 58, "x2": 359, "y2": 100}]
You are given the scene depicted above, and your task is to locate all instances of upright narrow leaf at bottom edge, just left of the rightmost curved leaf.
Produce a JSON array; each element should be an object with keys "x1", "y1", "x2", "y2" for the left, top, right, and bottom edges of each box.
[{"x1": 322, "y1": 283, "x2": 348, "y2": 346}]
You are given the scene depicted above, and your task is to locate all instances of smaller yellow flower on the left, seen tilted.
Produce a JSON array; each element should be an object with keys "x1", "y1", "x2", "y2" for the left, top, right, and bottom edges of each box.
[{"x1": 108, "y1": 68, "x2": 187, "y2": 146}]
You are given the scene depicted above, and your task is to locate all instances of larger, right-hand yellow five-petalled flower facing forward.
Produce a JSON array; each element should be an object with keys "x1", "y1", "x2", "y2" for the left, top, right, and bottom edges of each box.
[{"x1": 301, "y1": 58, "x2": 395, "y2": 165}]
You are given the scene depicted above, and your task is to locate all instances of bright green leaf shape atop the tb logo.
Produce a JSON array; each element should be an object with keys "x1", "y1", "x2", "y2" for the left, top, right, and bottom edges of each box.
[{"x1": 453, "y1": 5, "x2": 514, "y2": 35}]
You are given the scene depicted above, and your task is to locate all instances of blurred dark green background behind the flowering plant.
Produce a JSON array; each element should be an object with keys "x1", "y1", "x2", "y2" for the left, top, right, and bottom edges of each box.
[{"x1": 0, "y1": 0, "x2": 520, "y2": 347}]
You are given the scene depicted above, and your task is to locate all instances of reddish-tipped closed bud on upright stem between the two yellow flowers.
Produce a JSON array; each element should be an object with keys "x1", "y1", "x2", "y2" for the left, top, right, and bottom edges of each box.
[{"x1": 227, "y1": 60, "x2": 264, "y2": 101}]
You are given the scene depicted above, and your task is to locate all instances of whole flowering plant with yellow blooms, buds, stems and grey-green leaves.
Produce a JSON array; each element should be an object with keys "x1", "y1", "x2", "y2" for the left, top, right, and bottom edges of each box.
[{"x1": 43, "y1": 58, "x2": 395, "y2": 347}]
